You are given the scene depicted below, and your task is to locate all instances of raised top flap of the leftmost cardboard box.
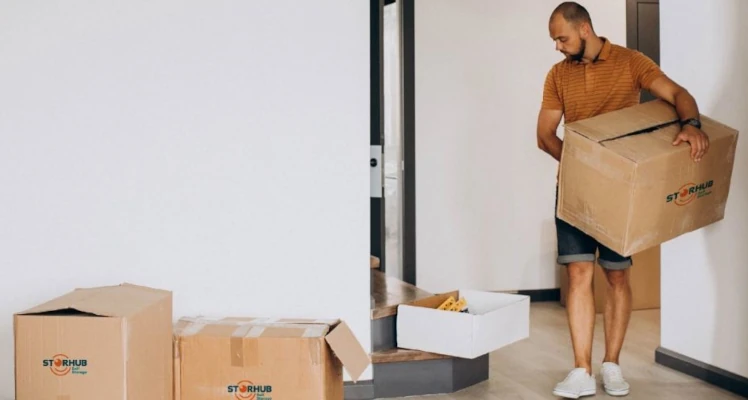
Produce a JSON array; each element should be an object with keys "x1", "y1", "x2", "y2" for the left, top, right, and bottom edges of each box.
[{"x1": 18, "y1": 283, "x2": 171, "y2": 317}]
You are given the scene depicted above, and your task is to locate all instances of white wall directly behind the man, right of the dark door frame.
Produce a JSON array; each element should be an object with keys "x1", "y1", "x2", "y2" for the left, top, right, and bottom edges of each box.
[{"x1": 415, "y1": 0, "x2": 626, "y2": 291}]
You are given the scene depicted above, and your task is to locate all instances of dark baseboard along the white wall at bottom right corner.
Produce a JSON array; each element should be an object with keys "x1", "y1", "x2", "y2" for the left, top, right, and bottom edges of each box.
[{"x1": 655, "y1": 347, "x2": 748, "y2": 398}]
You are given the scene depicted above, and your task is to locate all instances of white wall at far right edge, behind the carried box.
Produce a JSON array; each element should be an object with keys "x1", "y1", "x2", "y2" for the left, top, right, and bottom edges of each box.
[{"x1": 660, "y1": 0, "x2": 748, "y2": 376}]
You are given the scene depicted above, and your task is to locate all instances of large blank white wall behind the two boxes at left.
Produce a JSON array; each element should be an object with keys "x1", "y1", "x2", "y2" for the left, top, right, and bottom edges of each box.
[{"x1": 0, "y1": 0, "x2": 371, "y2": 399}]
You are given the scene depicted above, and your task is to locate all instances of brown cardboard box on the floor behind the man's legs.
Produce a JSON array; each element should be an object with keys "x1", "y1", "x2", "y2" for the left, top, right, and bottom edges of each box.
[{"x1": 560, "y1": 246, "x2": 660, "y2": 313}]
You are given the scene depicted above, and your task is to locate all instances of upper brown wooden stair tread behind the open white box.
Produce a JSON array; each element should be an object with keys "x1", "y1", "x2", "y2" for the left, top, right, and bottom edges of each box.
[{"x1": 371, "y1": 269, "x2": 433, "y2": 319}]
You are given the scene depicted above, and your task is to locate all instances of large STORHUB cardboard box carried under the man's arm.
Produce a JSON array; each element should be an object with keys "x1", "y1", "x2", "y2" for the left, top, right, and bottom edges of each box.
[{"x1": 557, "y1": 100, "x2": 738, "y2": 256}]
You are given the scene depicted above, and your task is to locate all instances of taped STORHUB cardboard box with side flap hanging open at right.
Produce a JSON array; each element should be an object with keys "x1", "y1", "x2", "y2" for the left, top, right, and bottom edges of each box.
[{"x1": 174, "y1": 317, "x2": 371, "y2": 400}]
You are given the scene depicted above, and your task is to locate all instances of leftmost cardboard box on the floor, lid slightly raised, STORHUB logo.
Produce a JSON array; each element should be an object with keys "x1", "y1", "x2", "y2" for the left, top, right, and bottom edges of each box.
[{"x1": 14, "y1": 284, "x2": 173, "y2": 400}]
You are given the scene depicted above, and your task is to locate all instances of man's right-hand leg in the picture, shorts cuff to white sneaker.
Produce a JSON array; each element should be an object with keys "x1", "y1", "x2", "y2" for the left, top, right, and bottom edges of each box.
[{"x1": 599, "y1": 246, "x2": 631, "y2": 396}]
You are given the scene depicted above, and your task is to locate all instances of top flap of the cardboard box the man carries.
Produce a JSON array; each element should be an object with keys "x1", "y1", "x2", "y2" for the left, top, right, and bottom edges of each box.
[{"x1": 565, "y1": 100, "x2": 678, "y2": 143}]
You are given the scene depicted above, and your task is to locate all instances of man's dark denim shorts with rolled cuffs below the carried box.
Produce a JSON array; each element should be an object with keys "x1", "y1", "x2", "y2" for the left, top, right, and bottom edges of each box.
[{"x1": 554, "y1": 187, "x2": 633, "y2": 270}]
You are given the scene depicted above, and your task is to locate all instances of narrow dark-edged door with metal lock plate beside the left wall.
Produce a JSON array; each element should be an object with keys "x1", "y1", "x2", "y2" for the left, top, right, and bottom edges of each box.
[{"x1": 370, "y1": 0, "x2": 408, "y2": 280}]
